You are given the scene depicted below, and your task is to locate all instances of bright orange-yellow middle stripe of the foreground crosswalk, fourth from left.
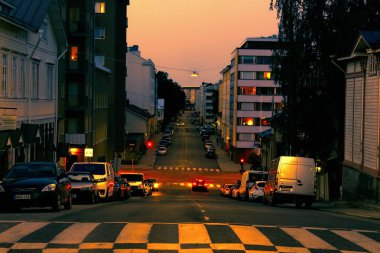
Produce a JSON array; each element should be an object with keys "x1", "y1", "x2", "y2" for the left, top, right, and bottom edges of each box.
[{"x1": 178, "y1": 224, "x2": 211, "y2": 244}]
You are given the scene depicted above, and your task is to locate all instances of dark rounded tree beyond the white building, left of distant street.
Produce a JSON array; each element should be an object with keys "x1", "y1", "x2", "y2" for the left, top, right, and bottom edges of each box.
[{"x1": 157, "y1": 71, "x2": 185, "y2": 126}]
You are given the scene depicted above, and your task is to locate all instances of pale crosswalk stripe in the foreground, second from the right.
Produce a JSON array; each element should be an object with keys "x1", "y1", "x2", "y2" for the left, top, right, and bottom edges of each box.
[{"x1": 282, "y1": 228, "x2": 336, "y2": 250}]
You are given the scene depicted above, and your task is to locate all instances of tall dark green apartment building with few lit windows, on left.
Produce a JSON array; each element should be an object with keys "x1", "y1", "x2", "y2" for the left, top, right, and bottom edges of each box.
[{"x1": 58, "y1": 0, "x2": 129, "y2": 167}]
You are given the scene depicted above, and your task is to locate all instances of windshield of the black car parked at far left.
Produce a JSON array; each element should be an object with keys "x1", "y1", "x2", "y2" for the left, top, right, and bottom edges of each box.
[{"x1": 6, "y1": 164, "x2": 56, "y2": 178}]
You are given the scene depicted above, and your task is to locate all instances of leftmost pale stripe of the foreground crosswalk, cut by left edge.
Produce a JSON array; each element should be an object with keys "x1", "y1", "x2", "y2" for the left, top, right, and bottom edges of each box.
[{"x1": 0, "y1": 222, "x2": 48, "y2": 243}]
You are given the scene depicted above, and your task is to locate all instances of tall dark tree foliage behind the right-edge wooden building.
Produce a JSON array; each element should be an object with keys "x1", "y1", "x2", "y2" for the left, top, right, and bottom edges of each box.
[{"x1": 271, "y1": 0, "x2": 380, "y2": 160}]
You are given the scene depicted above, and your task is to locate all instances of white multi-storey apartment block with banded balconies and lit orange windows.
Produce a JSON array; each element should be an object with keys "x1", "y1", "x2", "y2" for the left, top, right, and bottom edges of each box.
[{"x1": 226, "y1": 37, "x2": 283, "y2": 162}]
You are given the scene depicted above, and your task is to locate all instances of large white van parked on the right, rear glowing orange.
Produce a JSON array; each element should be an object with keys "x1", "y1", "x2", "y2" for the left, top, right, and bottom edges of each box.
[{"x1": 264, "y1": 156, "x2": 316, "y2": 208}]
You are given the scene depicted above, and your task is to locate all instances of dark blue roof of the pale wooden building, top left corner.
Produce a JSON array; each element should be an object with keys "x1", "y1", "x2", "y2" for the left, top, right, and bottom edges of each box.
[{"x1": 0, "y1": 0, "x2": 51, "y2": 32}]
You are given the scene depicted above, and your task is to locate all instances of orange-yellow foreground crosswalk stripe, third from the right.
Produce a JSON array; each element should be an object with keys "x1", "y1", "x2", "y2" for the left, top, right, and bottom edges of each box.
[{"x1": 230, "y1": 225, "x2": 273, "y2": 246}]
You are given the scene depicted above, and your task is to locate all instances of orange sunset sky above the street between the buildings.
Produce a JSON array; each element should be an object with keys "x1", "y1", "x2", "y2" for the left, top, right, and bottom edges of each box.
[{"x1": 127, "y1": 0, "x2": 278, "y2": 86}]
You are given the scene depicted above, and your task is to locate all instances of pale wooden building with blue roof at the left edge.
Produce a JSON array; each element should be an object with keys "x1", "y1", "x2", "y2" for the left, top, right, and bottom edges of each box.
[{"x1": 0, "y1": 0, "x2": 66, "y2": 175}]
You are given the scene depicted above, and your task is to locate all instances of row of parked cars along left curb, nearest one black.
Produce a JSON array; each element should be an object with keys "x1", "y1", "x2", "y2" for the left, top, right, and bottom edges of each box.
[{"x1": 0, "y1": 162, "x2": 158, "y2": 211}]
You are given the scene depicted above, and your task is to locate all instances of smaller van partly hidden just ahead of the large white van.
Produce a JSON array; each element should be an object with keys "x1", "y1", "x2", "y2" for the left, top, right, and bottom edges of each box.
[{"x1": 238, "y1": 170, "x2": 268, "y2": 200}]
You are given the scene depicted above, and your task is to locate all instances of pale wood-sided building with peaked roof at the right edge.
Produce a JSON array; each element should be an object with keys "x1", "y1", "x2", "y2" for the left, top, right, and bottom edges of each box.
[{"x1": 339, "y1": 31, "x2": 380, "y2": 201}]
